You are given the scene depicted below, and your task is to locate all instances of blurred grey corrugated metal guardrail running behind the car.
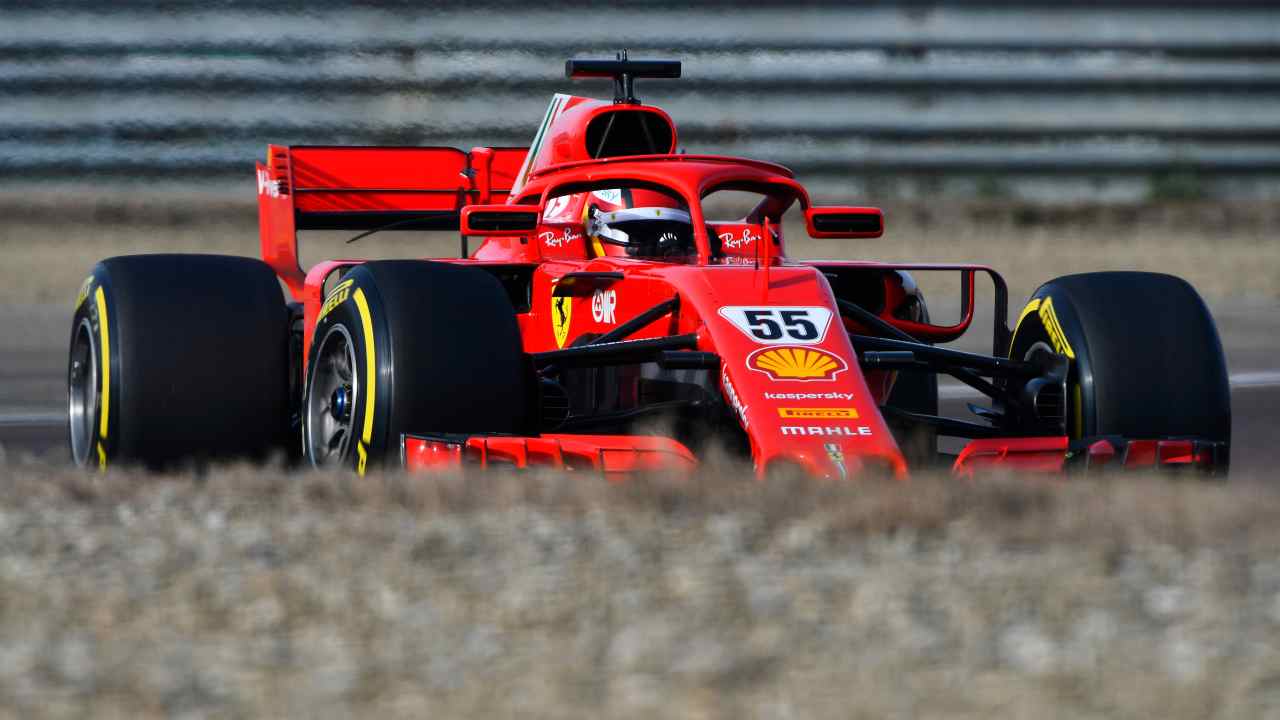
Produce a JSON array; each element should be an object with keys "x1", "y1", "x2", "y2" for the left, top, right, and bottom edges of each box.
[{"x1": 0, "y1": 0, "x2": 1280, "y2": 196}]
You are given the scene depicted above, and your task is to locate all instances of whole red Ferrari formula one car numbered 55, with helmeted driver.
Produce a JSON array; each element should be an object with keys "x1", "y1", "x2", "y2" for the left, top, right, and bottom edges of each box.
[{"x1": 69, "y1": 58, "x2": 1230, "y2": 478}]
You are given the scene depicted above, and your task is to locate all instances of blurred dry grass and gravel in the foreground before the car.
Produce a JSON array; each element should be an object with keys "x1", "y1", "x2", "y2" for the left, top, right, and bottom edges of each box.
[{"x1": 0, "y1": 456, "x2": 1280, "y2": 719}]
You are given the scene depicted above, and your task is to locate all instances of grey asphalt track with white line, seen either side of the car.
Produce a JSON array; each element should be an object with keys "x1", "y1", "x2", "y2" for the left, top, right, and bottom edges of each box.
[{"x1": 0, "y1": 300, "x2": 1280, "y2": 477}]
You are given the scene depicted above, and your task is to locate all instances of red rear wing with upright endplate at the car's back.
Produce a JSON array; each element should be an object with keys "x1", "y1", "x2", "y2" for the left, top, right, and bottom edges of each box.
[{"x1": 257, "y1": 145, "x2": 527, "y2": 297}]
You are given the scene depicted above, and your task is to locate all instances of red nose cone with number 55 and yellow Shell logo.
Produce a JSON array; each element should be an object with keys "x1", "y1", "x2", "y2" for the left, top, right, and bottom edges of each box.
[{"x1": 668, "y1": 258, "x2": 906, "y2": 479}]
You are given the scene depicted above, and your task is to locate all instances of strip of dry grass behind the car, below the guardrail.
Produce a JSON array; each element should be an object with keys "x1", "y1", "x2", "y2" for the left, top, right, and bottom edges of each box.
[{"x1": 0, "y1": 195, "x2": 1280, "y2": 304}]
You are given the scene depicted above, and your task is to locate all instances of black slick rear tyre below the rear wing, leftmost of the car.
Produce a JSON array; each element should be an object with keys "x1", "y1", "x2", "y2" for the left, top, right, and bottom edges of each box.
[{"x1": 68, "y1": 255, "x2": 289, "y2": 469}]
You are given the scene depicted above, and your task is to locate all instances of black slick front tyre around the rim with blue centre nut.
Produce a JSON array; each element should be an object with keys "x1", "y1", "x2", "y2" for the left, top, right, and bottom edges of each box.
[{"x1": 302, "y1": 260, "x2": 536, "y2": 473}]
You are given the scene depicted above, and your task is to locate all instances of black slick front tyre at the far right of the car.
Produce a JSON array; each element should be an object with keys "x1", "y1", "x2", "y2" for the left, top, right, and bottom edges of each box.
[{"x1": 1009, "y1": 272, "x2": 1231, "y2": 453}]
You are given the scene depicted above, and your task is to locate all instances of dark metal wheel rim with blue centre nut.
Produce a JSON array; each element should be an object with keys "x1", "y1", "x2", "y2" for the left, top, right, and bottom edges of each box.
[{"x1": 307, "y1": 325, "x2": 360, "y2": 468}]
